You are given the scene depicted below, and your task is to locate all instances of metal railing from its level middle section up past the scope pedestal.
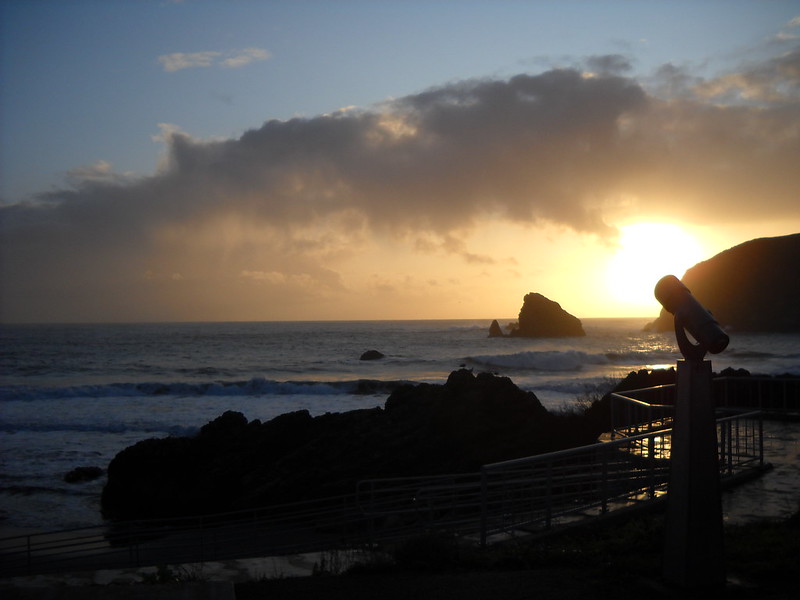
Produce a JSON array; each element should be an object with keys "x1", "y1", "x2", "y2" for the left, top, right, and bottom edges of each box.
[{"x1": 350, "y1": 412, "x2": 763, "y2": 544}]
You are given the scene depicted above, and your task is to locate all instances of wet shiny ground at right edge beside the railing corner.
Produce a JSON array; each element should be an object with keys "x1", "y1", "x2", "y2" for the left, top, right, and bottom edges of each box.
[{"x1": 722, "y1": 421, "x2": 800, "y2": 523}]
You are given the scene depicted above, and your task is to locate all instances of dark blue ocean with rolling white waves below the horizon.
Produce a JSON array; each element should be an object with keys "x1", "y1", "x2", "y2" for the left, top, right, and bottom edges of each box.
[{"x1": 0, "y1": 318, "x2": 800, "y2": 530}]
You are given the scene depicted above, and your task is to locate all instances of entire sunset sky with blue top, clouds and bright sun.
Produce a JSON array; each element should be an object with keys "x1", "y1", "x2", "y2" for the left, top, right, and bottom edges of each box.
[{"x1": 0, "y1": 0, "x2": 800, "y2": 322}]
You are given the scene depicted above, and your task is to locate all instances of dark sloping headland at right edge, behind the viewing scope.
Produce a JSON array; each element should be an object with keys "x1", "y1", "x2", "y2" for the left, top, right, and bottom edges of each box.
[{"x1": 647, "y1": 234, "x2": 800, "y2": 332}]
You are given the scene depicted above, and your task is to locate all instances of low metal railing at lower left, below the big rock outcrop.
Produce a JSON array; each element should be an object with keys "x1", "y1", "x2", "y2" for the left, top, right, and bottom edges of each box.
[{"x1": 0, "y1": 495, "x2": 369, "y2": 577}]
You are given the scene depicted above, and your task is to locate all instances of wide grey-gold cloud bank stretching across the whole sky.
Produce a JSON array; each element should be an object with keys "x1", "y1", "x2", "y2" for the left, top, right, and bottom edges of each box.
[{"x1": 0, "y1": 50, "x2": 800, "y2": 320}]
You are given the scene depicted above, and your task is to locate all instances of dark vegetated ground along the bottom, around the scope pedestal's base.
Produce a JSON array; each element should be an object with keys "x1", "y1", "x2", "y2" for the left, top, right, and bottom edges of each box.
[{"x1": 236, "y1": 513, "x2": 800, "y2": 600}]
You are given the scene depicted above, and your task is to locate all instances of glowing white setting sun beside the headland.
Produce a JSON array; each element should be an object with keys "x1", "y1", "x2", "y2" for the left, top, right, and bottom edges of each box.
[{"x1": 606, "y1": 223, "x2": 708, "y2": 316}]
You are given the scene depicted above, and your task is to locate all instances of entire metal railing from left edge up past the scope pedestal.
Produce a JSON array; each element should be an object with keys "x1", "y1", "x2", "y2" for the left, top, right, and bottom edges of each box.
[{"x1": 0, "y1": 412, "x2": 763, "y2": 577}]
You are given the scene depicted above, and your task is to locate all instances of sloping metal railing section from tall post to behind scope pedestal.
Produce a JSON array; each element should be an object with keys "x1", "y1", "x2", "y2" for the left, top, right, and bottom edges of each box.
[{"x1": 480, "y1": 412, "x2": 764, "y2": 543}]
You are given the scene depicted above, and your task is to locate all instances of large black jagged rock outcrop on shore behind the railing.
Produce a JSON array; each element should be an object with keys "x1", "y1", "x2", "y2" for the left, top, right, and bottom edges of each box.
[{"x1": 102, "y1": 369, "x2": 606, "y2": 519}]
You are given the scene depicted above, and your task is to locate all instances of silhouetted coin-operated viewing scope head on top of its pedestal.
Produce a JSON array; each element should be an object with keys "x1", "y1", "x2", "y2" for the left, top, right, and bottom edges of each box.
[{"x1": 655, "y1": 275, "x2": 730, "y2": 360}]
